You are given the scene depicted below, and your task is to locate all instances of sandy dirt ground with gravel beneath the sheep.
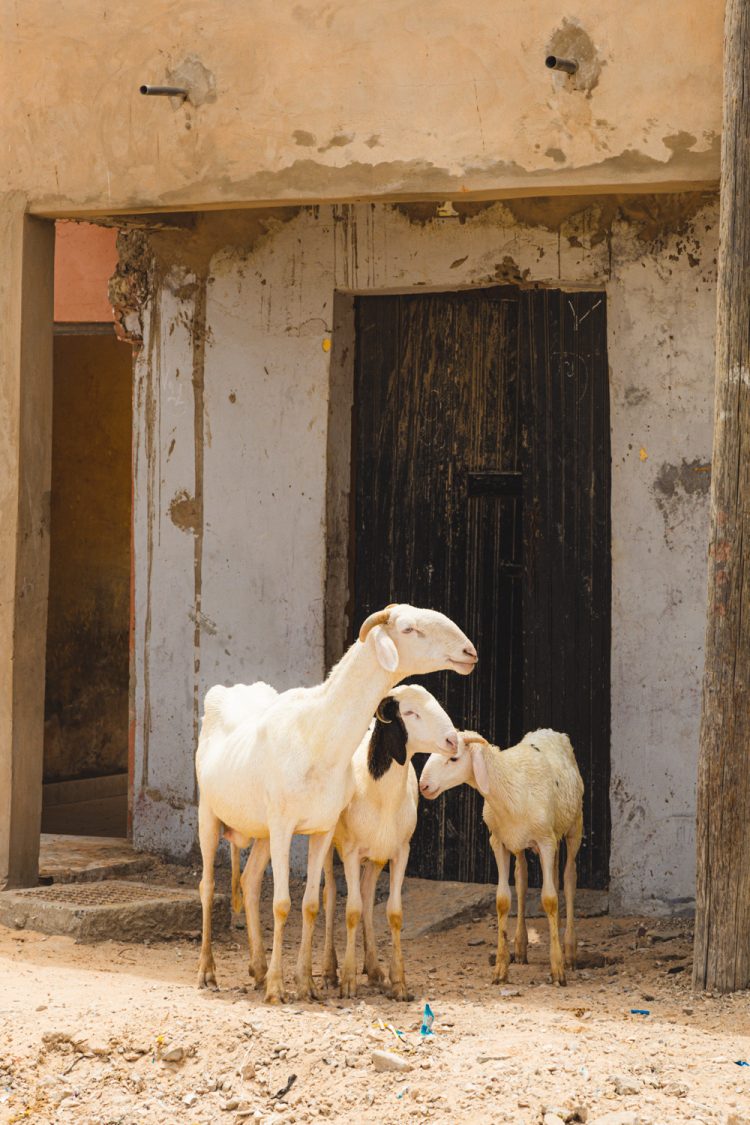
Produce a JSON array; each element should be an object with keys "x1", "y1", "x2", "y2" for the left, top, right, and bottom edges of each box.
[{"x1": 0, "y1": 866, "x2": 750, "y2": 1125}]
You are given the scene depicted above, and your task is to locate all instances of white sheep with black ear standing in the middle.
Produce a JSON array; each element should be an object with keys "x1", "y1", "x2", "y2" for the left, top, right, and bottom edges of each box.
[{"x1": 323, "y1": 684, "x2": 458, "y2": 1000}]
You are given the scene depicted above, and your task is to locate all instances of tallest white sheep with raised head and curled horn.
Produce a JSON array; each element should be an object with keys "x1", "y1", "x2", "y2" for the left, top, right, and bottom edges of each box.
[{"x1": 196, "y1": 604, "x2": 477, "y2": 1002}]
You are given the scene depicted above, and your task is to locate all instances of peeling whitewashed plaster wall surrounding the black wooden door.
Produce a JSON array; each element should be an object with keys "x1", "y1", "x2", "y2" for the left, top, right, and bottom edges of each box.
[{"x1": 134, "y1": 195, "x2": 717, "y2": 912}]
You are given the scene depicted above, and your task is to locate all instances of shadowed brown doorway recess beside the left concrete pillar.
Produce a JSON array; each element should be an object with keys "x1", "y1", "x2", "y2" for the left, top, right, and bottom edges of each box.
[{"x1": 42, "y1": 323, "x2": 133, "y2": 837}]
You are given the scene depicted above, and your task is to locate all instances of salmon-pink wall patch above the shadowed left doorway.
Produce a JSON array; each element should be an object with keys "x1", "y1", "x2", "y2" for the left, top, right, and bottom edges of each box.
[{"x1": 55, "y1": 221, "x2": 117, "y2": 322}]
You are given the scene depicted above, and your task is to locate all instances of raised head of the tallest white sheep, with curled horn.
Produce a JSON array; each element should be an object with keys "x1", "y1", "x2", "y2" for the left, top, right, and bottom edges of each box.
[{"x1": 360, "y1": 603, "x2": 477, "y2": 680}]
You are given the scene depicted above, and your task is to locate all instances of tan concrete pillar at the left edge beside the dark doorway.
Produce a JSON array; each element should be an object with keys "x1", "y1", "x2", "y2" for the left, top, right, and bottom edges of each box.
[{"x1": 0, "y1": 192, "x2": 55, "y2": 888}]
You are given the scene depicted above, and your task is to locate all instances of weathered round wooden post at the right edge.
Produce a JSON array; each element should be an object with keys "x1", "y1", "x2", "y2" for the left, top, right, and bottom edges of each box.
[{"x1": 693, "y1": 0, "x2": 750, "y2": 992}]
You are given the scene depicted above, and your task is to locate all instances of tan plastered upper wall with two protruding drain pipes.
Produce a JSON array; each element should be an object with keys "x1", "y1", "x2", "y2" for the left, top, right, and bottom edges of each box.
[{"x1": 0, "y1": 0, "x2": 723, "y2": 215}]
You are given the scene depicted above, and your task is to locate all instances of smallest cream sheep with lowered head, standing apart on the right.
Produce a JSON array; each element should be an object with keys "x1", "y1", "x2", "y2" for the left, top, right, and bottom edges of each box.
[{"x1": 419, "y1": 730, "x2": 584, "y2": 984}]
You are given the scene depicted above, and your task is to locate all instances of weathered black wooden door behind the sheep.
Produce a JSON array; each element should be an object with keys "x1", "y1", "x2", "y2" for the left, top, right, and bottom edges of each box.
[{"x1": 353, "y1": 287, "x2": 609, "y2": 885}]
